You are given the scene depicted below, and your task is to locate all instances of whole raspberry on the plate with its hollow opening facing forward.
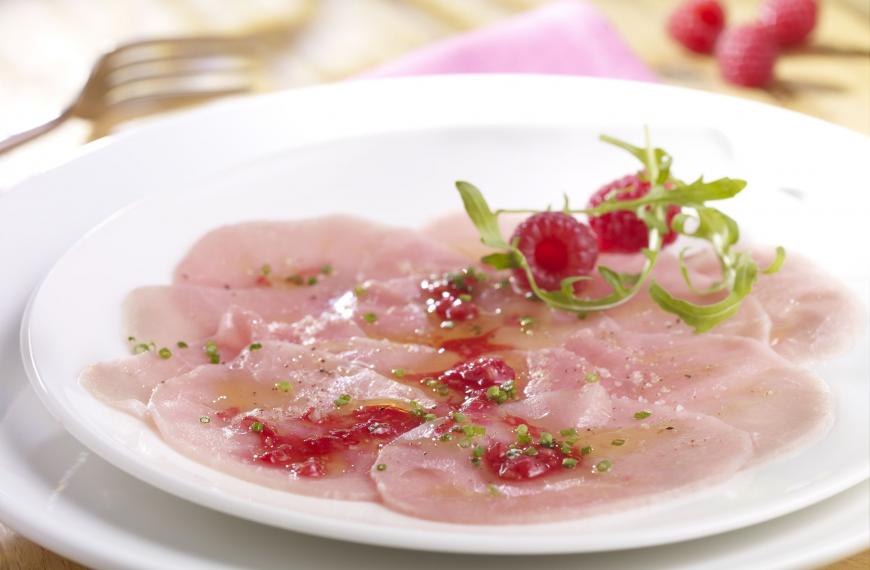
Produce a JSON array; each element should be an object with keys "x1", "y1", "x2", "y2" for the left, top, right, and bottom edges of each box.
[{"x1": 511, "y1": 212, "x2": 598, "y2": 291}]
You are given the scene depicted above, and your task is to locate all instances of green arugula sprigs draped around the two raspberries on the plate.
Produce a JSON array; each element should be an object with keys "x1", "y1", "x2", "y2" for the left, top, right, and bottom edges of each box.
[{"x1": 456, "y1": 126, "x2": 785, "y2": 330}]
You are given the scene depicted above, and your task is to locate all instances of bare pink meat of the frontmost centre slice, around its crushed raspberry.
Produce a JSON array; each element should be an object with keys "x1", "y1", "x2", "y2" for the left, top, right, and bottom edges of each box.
[{"x1": 372, "y1": 399, "x2": 752, "y2": 524}]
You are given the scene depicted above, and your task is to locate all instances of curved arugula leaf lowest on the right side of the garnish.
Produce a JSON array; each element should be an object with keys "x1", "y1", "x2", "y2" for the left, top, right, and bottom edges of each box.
[{"x1": 649, "y1": 254, "x2": 758, "y2": 333}]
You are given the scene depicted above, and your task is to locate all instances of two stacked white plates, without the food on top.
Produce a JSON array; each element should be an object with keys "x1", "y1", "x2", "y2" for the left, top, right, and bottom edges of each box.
[{"x1": 0, "y1": 76, "x2": 870, "y2": 569}]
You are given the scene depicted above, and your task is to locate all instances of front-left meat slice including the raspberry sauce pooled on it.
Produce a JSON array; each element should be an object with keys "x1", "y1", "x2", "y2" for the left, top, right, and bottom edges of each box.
[{"x1": 148, "y1": 341, "x2": 433, "y2": 500}]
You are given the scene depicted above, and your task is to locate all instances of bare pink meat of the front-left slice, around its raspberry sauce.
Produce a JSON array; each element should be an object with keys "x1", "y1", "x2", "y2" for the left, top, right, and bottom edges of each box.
[{"x1": 148, "y1": 341, "x2": 433, "y2": 500}]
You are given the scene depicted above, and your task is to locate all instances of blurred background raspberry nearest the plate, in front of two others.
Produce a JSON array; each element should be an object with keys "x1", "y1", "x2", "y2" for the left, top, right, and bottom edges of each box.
[{"x1": 716, "y1": 24, "x2": 779, "y2": 87}]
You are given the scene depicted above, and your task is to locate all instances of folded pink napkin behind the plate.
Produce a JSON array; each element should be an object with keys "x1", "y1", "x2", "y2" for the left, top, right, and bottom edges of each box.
[{"x1": 362, "y1": 1, "x2": 655, "y2": 81}]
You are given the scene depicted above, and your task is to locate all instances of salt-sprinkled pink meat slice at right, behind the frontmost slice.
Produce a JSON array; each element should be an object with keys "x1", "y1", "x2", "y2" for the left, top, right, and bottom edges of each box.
[{"x1": 555, "y1": 322, "x2": 833, "y2": 461}]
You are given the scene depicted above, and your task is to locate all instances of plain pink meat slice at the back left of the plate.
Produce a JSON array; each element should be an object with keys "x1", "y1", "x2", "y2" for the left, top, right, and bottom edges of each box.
[{"x1": 175, "y1": 216, "x2": 468, "y2": 291}]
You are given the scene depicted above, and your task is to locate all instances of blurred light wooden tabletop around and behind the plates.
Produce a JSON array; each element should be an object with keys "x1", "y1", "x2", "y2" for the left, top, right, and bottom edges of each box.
[{"x1": 0, "y1": 0, "x2": 870, "y2": 570}]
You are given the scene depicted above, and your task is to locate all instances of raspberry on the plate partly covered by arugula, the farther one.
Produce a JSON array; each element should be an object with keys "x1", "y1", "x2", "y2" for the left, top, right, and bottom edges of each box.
[{"x1": 588, "y1": 174, "x2": 680, "y2": 253}]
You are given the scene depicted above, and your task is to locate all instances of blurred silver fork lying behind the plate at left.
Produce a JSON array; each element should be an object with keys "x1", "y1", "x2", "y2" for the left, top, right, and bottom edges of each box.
[{"x1": 0, "y1": 36, "x2": 265, "y2": 154}]
